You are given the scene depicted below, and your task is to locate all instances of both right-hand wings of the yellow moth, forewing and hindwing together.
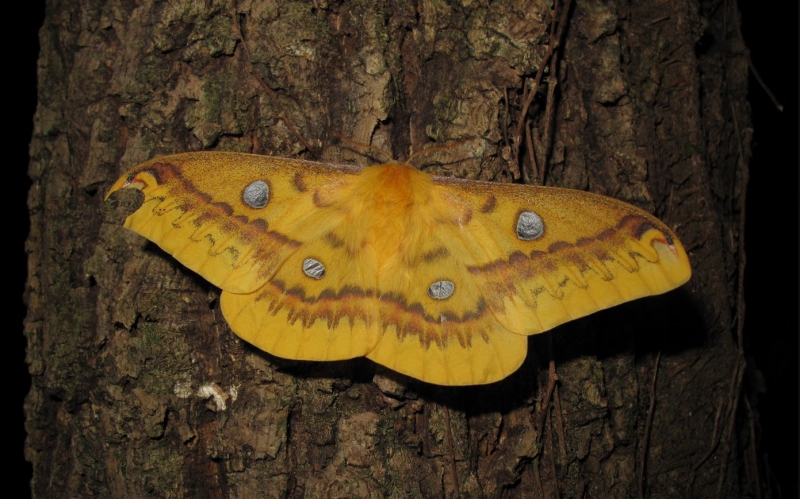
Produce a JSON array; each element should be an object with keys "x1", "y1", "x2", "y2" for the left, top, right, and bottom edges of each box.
[{"x1": 368, "y1": 179, "x2": 691, "y2": 385}]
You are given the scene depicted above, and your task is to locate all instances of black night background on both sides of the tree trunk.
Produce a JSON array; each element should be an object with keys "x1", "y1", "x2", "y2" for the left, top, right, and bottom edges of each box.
[{"x1": 10, "y1": 0, "x2": 800, "y2": 498}]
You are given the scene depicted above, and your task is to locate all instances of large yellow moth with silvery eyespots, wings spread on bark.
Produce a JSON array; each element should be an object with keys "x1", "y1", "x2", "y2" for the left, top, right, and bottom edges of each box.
[{"x1": 106, "y1": 152, "x2": 691, "y2": 385}]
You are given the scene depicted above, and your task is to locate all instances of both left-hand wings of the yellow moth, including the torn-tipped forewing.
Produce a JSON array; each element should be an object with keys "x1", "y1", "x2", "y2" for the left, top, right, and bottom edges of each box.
[{"x1": 109, "y1": 152, "x2": 376, "y2": 360}]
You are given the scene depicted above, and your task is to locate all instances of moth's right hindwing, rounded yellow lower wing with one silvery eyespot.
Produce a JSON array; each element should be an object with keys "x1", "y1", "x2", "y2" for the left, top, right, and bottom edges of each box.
[{"x1": 367, "y1": 242, "x2": 528, "y2": 385}]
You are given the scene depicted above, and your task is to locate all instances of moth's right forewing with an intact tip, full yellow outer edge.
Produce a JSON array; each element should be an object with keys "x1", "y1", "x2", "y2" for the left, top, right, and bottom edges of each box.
[{"x1": 437, "y1": 179, "x2": 691, "y2": 334}]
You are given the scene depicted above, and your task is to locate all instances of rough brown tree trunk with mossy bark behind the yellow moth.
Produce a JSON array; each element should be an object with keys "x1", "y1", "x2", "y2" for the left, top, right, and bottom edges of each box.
[{"x1": 25, "y1": 0, "x2": 758, "y2": 497}]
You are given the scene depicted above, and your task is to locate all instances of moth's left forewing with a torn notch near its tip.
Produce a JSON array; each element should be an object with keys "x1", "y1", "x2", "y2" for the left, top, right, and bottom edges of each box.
[{"x1": 109, "y1": 152, "x2": 350, "y2": 293}]
